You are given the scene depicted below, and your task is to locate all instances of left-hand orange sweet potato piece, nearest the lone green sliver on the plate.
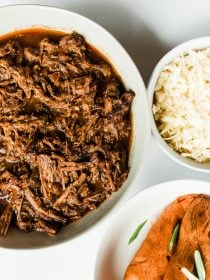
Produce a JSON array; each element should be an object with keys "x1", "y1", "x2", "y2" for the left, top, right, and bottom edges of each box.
[{"x1": 124, "y1": 194, "x2": 200, "y2": 280}]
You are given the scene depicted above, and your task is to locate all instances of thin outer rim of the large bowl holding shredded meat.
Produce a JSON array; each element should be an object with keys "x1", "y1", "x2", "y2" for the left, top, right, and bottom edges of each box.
[{"x1": 0, "y1": 4, "x2": 151, "y2": 250}]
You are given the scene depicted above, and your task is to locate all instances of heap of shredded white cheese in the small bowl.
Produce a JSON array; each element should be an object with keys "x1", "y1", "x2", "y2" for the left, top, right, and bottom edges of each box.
[{"x1": 152, "y1": 48, "x2": 210, "y2": 162}]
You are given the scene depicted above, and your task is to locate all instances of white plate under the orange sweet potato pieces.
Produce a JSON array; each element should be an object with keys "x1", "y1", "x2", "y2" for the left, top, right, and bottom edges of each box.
[{"x1": 95, "y1": 180, "x2": 210, "y2": 280}]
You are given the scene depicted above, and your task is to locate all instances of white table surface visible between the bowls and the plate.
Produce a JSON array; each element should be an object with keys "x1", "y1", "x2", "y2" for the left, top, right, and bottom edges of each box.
[{"x1": 0, "y1": 0, "x2": 210, "y2": 280}]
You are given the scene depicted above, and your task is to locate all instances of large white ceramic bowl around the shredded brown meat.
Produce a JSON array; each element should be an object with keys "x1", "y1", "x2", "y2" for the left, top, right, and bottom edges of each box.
[{"x1": 0, "y1": 5, "x2": 150, "y2": 249}]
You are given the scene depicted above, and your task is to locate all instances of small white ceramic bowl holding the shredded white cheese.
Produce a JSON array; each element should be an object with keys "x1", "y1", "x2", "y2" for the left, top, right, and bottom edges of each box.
[{"x1": 147, "y1": 37, "x2": 210, "y2": 172}]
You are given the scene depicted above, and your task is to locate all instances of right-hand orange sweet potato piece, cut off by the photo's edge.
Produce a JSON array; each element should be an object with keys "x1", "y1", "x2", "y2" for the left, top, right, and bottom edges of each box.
[{"x1": 163, "y1": 196, "x2": 210, "y2": 280}]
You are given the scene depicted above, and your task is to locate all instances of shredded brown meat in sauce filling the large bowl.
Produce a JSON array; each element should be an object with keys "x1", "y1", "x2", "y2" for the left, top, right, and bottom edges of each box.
[{"x1": 0, "y1": 28, "x2": 134, "y2": 236}]
